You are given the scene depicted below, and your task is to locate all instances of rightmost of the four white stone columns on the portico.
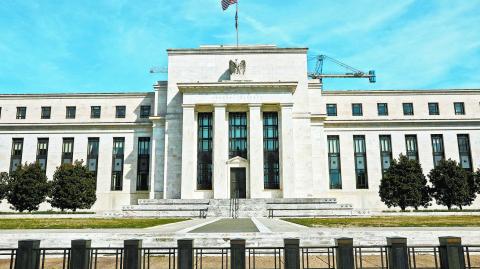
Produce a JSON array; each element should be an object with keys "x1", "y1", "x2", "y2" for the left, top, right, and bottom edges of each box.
[{"x1": 280, "y1": 104, "x2": 295, "y2": 198}]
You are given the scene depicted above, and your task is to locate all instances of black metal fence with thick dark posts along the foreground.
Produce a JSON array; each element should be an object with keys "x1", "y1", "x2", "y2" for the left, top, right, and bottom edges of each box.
[{"x1": 0, "y1": 237, "x2": 480, "y2": 269}]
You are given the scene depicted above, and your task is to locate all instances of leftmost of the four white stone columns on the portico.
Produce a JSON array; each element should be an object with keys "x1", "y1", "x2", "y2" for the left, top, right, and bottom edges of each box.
[{"x1": 179, "y1": 105, "x2": 197, "y2": 199}]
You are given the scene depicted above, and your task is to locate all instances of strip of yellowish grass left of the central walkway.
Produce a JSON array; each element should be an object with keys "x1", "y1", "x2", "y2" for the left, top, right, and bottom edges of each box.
[{"x1": 0, "y1": 218, "x2": 187, "y2": 230}]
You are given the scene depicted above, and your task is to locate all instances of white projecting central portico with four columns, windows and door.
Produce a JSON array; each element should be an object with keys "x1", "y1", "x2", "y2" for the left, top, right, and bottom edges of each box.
[{"x1": 177, "y1": 80, "x2": 298, "y2": 199}]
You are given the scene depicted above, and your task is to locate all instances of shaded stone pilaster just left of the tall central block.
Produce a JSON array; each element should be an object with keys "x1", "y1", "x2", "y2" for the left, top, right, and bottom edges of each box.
[{"x1": 149, "y1": 116, "x2": 165, "y2": 199}]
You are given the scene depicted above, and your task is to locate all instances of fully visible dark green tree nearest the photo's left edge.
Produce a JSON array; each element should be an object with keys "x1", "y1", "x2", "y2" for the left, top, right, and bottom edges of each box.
[{"x1": 6, "y1": 163, "x2": 50, "y2": 212}]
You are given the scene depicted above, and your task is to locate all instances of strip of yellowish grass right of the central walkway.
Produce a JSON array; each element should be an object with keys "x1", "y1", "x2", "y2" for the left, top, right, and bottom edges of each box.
[{"x1": 284, "y1": 216, "x2": 480, "y2": 228}]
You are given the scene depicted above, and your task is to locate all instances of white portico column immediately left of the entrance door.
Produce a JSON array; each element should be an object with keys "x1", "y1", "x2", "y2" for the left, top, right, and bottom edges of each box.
[{"x1": 213, "y1": 104, "x2": 230, "y2": 199}]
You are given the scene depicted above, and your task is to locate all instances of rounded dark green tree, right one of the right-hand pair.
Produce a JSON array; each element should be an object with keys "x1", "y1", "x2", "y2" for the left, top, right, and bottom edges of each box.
[{"x1": 428, "y1": 159, "x2": 477, "y2": 210}]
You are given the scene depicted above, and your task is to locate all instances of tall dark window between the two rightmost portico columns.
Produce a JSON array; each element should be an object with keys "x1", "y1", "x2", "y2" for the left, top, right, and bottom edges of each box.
[{"x1": 263, "y1": 112, "x2": 280, "y2": 189}]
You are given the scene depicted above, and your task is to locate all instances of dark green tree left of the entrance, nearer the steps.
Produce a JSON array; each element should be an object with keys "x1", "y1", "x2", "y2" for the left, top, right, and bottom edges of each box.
[{"x1": 50, "y1": 161, "x2": 97, "y2": 211}]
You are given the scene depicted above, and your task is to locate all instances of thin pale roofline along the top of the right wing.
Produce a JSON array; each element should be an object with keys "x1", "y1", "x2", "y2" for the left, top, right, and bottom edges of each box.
[{"x1": 322, "y1": 89, "x2": 480, "y2": 95}]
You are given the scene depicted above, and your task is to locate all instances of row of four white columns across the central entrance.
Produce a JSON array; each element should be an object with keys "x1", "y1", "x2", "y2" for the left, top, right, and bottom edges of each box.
[{"x1": 182, "y1": 104, "x2": 294, "y2": 199}]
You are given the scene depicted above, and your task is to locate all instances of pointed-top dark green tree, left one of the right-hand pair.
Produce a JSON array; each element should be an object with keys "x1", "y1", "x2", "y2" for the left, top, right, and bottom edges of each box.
[{"x1": 379, "y1": 154, "x2": 432, "y2": 211}]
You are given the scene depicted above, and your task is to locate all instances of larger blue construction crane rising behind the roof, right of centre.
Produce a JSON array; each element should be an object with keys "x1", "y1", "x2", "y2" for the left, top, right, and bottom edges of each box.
[{"x1": 308, "y1": 55, "x2": 377, "y2": 83}]
